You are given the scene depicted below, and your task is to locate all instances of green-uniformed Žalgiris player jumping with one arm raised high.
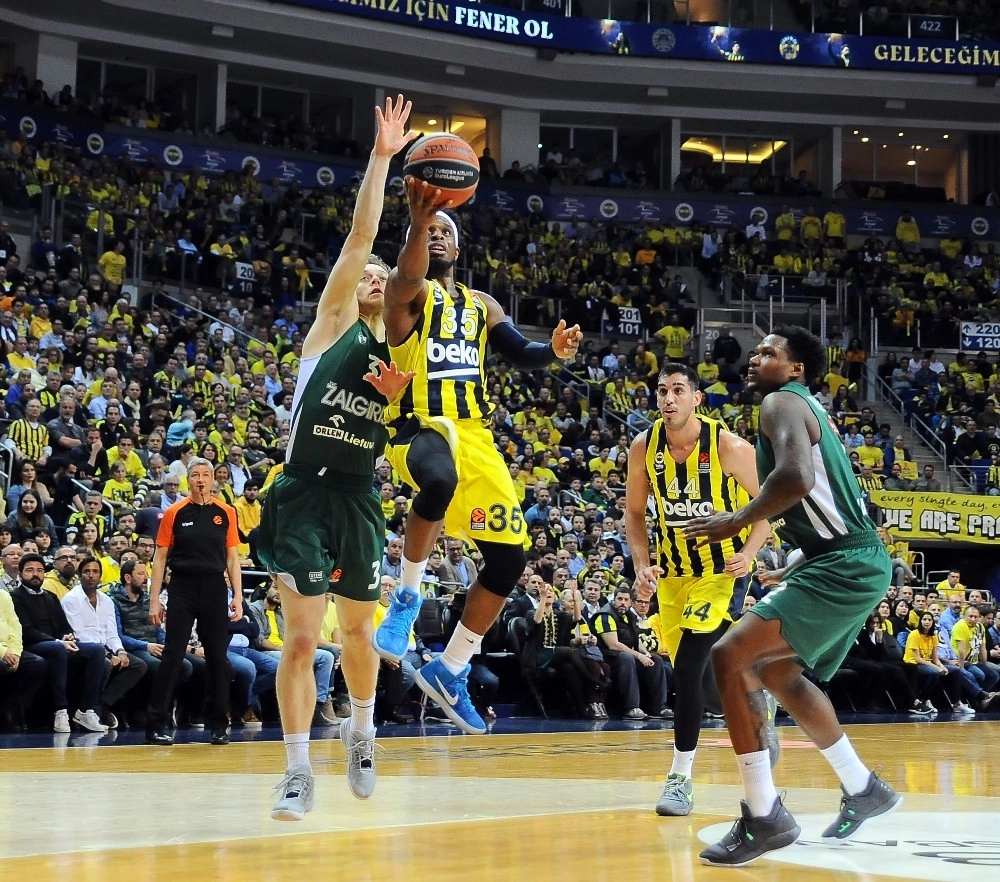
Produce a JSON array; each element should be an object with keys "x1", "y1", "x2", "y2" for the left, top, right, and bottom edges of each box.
[{"x1": 258, "y1": 95, "x2": 416, "y2": 820}]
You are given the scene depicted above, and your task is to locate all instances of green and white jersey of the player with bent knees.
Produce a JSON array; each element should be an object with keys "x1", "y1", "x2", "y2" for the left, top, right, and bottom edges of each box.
[{"x1": 757, "y1": 382, "x2": 881, "y2": 555}]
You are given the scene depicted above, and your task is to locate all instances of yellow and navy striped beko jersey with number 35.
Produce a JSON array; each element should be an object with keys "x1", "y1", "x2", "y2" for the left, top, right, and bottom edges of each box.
[{"x1": 386, "y1": 280, "x2": 493, "y2": 422}]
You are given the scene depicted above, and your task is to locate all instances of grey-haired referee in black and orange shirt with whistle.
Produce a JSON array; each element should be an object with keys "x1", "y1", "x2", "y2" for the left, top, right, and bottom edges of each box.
[{"x1": 146, "y1": 457, "x2": 243, "y2": 744}]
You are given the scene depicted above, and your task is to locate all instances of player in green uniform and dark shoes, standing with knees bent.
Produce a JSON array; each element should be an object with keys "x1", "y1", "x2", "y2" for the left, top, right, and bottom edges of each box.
[{"x1": 685, "y1": 325, "x2": 901, "y2": 866}]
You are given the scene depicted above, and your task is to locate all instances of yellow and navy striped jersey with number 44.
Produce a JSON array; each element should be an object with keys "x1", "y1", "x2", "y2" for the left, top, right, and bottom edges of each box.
[{"x1": 646, "y1": 416, "x2": 750, "y2": 578}]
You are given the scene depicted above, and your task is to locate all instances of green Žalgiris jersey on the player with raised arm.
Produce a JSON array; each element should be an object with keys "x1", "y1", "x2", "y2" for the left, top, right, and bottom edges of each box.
[{"x1": 285, "y1": 319, "x2": 389, "y2": 481}]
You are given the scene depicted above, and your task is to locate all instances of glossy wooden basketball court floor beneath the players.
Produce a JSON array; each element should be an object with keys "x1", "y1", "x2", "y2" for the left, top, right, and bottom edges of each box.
[{"x1": 0, "y1": 720, "x2": 1000, "y2": 882}]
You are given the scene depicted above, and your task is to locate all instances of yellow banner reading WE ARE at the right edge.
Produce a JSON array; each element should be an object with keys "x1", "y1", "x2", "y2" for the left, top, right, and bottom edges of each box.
[{"x1": 869, "y1": 490, "x2": 1000, "y2": 543}]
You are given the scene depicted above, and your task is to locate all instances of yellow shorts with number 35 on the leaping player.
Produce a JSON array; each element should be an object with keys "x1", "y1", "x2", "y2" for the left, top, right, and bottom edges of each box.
[{"x1": 386, "y1": 415, "x2": 527, "y2": 545}]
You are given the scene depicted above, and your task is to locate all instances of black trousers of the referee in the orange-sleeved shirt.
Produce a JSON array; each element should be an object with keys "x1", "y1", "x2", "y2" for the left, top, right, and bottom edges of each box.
[{"x1": 148, "y1": 573, "x2": 230, "y2": 731}]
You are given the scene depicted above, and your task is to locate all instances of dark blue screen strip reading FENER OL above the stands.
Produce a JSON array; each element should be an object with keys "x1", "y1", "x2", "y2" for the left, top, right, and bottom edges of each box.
[{"x1": 282, "y1": 0, "x2": 1000, "y2": 76}]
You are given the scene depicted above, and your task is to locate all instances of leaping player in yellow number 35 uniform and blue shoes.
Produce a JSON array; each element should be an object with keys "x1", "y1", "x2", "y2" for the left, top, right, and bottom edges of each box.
[{"x1": 372, "y1": 177, "x2": 582, "y2": 734}]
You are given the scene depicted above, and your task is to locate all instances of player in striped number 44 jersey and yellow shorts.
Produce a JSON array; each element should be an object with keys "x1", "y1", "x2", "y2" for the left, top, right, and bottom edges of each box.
[{"x1": 625, "y1": 363, "x2": 770, "y2": 815}]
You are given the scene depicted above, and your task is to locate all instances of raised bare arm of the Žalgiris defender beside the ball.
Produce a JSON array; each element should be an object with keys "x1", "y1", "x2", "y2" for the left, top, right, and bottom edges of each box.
[{"x1": 316, "y1": 95, "x2": 417, "y2": 322}]
